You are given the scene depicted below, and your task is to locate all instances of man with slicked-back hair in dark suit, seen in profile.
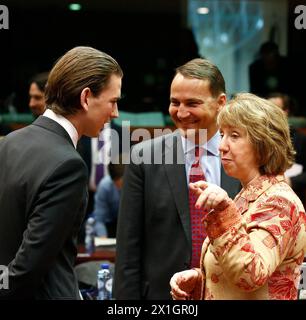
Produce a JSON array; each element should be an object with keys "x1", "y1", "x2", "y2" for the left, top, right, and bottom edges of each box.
[{"x1": 0, "y1": 47, "x2": 123, "y2": 299}]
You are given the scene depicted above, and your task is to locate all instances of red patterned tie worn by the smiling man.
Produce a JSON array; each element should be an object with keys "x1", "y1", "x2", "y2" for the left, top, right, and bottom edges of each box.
[{"x1": 189, "y1": 146, "x2": 206, "y2": 268}]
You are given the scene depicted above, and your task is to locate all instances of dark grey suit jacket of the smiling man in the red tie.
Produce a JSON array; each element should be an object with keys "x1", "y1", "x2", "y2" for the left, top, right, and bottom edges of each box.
[{"x1": 114, "y1": 133, "x2": 240, "y2": 299}]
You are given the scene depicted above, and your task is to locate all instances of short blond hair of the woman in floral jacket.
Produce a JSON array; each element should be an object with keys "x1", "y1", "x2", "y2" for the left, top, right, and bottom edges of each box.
[{"x1": 217, "y1": 93, "x2": 295, "y2": 175}]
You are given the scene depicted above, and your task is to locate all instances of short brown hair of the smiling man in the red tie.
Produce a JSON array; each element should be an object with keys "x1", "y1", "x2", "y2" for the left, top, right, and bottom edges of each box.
[{"x1": 176, "y1": 58, "x2": 226, "y2": 98}]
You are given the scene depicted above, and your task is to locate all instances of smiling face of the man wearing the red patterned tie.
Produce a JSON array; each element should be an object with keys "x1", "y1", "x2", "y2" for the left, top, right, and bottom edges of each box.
[{"x1": 169, "y1": 73, "x2": 226, "y2": 143}]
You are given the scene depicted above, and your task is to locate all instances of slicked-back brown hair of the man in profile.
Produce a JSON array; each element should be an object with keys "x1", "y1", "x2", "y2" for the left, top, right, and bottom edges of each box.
[{"x1": 45, "y1": 47, "x2": 123, "y2": 116}]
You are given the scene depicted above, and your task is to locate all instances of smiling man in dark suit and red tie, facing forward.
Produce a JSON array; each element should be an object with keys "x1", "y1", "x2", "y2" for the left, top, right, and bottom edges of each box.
[{"x1": 114, "y1": 59, "x2": 240, "y2": 299}]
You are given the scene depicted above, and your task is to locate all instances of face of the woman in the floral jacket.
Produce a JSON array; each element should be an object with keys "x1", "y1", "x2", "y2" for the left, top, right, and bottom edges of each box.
[{"x1": 219, "y1": 126, "x2": 260, "y2": 186}]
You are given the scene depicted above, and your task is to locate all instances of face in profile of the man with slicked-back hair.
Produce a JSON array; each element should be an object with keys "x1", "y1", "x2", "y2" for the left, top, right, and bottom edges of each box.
[{"x1": 81, "y1": 74, "x2": 121, "y2": 137}]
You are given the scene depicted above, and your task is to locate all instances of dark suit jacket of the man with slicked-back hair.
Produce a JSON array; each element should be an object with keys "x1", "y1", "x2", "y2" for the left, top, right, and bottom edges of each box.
[{"x1": 0, "y1": 116, "x2": 87, "y2": 299}]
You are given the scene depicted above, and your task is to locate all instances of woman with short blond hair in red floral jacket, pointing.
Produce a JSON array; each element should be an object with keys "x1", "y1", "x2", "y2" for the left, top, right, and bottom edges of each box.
[{"x1": 170, "y1": 94, "x2": 306, "y2": 300}]
